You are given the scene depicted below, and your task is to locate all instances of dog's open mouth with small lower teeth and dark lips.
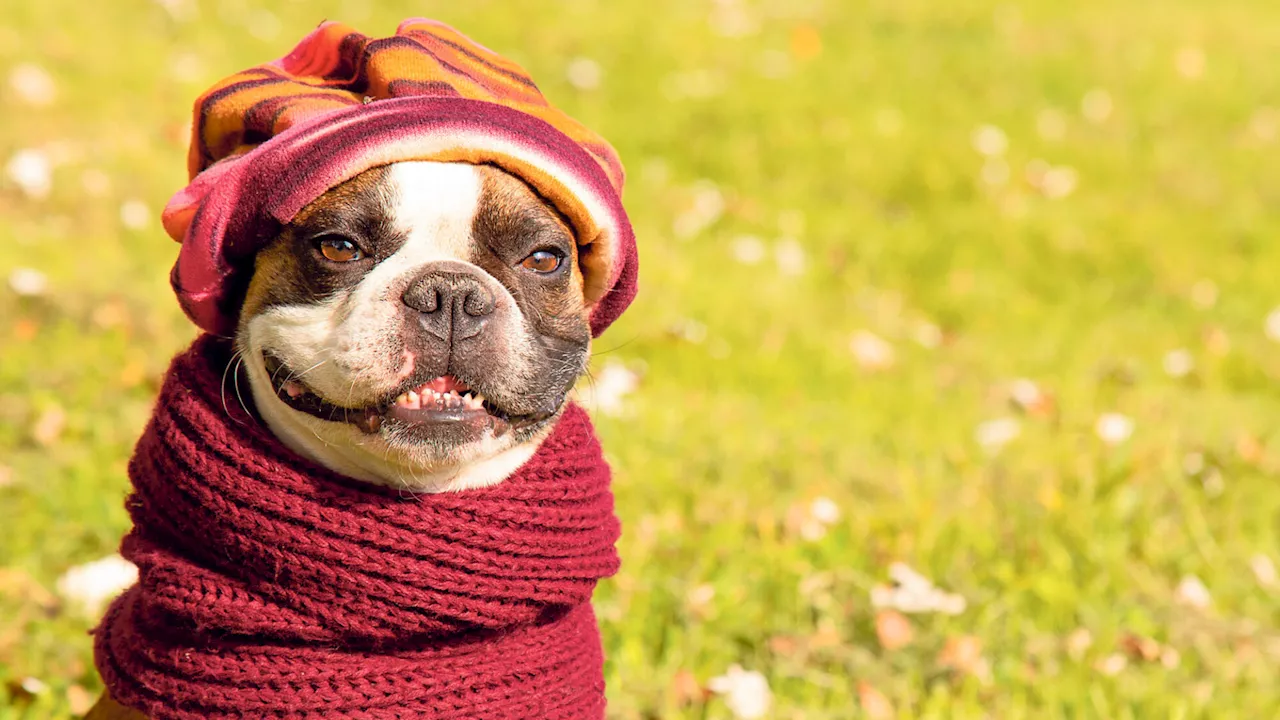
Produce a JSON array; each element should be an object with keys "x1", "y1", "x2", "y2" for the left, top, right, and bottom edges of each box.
[{"x1": 262, "y1": 352, "x2": 549, "y2": 436}]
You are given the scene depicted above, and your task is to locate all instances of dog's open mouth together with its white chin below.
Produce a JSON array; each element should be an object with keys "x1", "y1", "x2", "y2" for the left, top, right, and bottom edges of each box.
[{"x1": 246, "y1": 354, "x2": 563, "y2": 492}]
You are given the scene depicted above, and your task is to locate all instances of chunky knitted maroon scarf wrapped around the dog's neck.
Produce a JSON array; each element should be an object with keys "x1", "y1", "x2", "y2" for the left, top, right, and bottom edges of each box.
[{"x1": 95, "y1": 336, "x2": 618, "y2": 720}]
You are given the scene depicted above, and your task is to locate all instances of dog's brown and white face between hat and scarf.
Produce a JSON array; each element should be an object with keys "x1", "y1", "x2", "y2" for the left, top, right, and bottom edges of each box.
[{"x1": 237, "y1": 161, "x2": 591, "y2": 491}]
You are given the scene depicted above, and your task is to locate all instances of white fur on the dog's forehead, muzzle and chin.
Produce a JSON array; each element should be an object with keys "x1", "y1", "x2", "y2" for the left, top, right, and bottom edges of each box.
[{"x1": 239, "y1": 161, "x2": 541, "y2": 492}]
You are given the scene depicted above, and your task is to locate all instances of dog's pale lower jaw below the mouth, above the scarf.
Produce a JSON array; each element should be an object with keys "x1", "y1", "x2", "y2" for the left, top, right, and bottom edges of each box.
[{"x1": 242, "y1": 347, "x2": 547, "y2": 492}]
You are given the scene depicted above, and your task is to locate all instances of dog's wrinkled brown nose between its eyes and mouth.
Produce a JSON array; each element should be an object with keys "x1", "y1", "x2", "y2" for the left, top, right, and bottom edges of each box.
[{"x1": 401, "y1": 269, "x2": 497, "y2": 342}]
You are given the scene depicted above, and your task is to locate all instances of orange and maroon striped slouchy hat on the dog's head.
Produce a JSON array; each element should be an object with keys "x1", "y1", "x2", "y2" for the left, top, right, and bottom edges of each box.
[{"x1": 164, "y1": 18, "x2": 637, "y2": 336}]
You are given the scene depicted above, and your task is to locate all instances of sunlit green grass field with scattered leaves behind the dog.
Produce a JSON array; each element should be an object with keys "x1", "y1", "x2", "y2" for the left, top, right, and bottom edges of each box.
[{"x1": 0, "y1": 0, "x2": 1280, "y2": 720}]
